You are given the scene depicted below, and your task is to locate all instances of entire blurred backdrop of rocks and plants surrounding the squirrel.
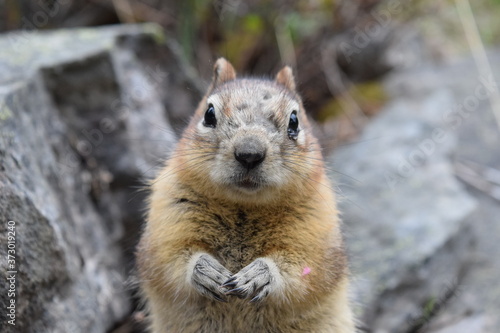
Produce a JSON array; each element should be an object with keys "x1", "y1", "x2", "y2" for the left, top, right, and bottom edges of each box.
[{"x1": 0, "y1": 0, "x2": 500, "y2": 333}]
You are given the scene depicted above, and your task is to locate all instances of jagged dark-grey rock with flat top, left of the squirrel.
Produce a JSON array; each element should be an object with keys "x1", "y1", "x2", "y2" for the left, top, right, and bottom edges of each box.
[{"x1": 0, "y1": 25, "x2": 195, "y2": 333}]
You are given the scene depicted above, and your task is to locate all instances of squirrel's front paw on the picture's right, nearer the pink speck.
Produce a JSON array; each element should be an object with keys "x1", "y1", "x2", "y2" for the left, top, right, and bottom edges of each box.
[{"x1": 222, "y1": 258, "x2": 282, "y2": 303}]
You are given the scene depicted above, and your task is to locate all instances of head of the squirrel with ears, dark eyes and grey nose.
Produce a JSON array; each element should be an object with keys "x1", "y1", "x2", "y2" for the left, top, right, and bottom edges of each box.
[{"x1": 174, "y1": 58, "x2": 324, "y2": 204}]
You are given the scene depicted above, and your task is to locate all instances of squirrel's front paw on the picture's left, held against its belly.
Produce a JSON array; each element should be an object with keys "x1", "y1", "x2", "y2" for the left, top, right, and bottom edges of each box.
[{"x1": 190, "y1": 253, "x2": 231, "y2": 302}]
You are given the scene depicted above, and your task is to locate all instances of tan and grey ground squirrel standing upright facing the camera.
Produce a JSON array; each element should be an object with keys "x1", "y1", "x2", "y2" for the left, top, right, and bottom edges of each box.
[{"x1": 137, "y1": 58, "x2": 355, "y2": 333}]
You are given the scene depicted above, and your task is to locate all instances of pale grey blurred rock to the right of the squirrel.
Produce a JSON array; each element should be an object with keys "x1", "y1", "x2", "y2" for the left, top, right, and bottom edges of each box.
[{"x1": 331, "y1": 53, "x2": 500, "y2": 333}]
